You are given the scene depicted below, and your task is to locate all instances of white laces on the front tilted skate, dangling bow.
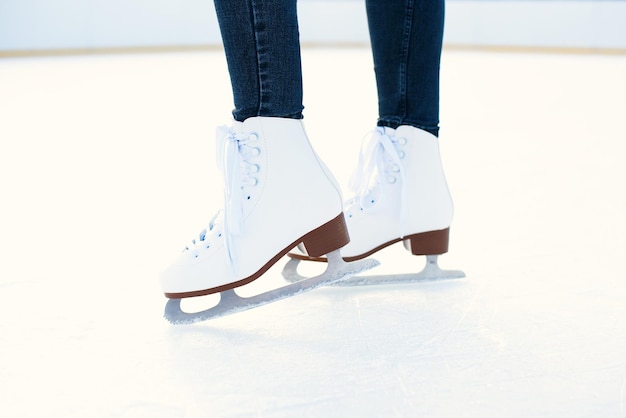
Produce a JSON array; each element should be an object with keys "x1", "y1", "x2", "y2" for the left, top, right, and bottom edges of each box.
[{"x1": 185, "y1": 126, "x2": 260, "y2": 275}]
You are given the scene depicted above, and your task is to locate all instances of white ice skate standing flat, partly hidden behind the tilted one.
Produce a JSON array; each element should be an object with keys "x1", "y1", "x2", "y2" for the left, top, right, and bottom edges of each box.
[{"x1": 283, "y1": 126, "x2": 465, "y2": 285}]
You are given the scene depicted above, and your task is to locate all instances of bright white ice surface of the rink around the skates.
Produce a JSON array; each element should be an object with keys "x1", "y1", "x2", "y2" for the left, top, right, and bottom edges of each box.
[{"x1": 0, "y1": 48, "x2": 626, "y2": 418}]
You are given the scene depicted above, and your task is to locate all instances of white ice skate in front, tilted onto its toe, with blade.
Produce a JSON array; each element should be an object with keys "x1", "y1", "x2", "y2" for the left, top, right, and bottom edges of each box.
[{"x1": 161, "y1": 117, "x2": 376, "y2": 323}]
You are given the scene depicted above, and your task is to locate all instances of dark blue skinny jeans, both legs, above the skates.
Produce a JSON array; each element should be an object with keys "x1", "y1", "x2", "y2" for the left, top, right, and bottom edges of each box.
[{"x1": 215, "y1": 0, "x2": 444, "y2": 135}]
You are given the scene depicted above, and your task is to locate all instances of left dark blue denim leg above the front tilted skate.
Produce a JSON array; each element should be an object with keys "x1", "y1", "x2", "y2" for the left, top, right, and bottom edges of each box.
[{"x1": 215, "y1": 0, "x2": 303, "y2": 122}]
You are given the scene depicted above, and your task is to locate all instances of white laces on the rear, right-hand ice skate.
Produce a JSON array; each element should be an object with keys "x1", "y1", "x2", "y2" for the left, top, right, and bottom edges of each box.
[{"x1": 345, "y1": 127, "x2": 407, "y2": 236}]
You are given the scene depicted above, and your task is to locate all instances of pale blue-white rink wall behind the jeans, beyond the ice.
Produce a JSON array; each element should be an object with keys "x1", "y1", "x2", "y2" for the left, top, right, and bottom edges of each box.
[{"x1": 0, "y1": 0, "x2": 626, "y2": 54}]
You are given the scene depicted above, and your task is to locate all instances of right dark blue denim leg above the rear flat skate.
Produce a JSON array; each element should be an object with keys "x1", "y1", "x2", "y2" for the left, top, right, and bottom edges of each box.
[{"x1": 366, "y1": 0, "x2": 445, "y2": 136}]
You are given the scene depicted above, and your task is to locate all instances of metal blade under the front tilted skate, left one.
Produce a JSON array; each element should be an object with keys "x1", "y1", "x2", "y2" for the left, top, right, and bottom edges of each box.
[{"x1": 164, "y1": 251, "x2": 378, "y2": 325}]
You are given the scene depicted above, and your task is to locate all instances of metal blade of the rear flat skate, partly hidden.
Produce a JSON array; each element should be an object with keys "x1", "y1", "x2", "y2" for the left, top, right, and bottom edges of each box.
[{"x1": 282, "y1": 255, "x2": 465, "y2": 286}]
